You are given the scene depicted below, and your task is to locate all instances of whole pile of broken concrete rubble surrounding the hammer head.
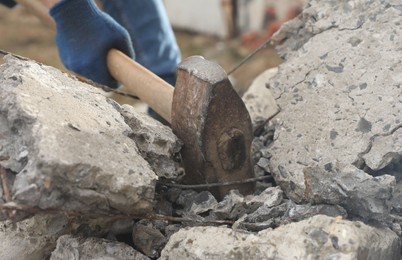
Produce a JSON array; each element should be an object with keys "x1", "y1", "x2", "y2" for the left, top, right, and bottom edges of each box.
[{"x1": 0, "y1": 0, "x2": 402, "y2": 259}]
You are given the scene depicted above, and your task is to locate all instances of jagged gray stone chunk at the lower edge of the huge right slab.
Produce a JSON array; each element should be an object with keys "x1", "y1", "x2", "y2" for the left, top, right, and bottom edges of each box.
[{"x1": 304, "y1": 166, "x2": 395, "y2": 222}]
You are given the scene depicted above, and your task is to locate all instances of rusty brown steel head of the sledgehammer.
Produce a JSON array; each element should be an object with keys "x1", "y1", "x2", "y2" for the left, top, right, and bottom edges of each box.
[{"x1": 171, "y1": 56, "x2": 254, "y2": 198}]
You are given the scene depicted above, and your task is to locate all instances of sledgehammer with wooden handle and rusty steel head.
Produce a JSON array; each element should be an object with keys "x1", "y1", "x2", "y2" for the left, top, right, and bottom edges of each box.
[{"x1": 19, "y1": 0, "x2": 254, "y2": 198}]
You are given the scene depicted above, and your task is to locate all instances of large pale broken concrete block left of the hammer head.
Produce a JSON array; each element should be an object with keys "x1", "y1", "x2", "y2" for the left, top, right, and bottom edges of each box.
[{"x1": 0, "y1": 56, "x2": 157, "y2": 214}]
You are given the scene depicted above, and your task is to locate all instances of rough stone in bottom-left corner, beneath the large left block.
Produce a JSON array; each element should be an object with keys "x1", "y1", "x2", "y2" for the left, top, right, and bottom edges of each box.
[{"x1": 0, "y1": 215, "x2": 68, "y2": 259}]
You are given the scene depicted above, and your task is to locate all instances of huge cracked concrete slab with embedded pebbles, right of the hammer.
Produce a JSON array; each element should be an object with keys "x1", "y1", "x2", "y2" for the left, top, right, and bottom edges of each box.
[{"x1": 269, "y1": 0, "x2": 402, "y2": 219}]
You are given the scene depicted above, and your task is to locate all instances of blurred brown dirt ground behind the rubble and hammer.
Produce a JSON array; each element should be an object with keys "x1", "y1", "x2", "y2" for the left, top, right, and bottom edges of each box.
[{"x1": 0, "y1": 5, "x2": 281, "y2": 103}]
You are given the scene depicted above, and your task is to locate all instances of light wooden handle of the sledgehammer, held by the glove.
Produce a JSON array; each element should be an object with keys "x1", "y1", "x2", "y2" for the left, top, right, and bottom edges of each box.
[{"x1": 15, "y1": 0, "x2": 174, "y2": 123}]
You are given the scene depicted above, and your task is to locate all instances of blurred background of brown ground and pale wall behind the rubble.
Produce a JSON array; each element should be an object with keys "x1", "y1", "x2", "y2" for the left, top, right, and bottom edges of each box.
[{"x1": 0, "y1": 0, "x2": 305, "y2": 103}]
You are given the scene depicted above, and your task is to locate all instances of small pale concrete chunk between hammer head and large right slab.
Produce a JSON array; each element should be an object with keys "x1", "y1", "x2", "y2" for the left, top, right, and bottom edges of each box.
[{"x1": 242, "y1": 68, "x2": 279, "y2": 129}]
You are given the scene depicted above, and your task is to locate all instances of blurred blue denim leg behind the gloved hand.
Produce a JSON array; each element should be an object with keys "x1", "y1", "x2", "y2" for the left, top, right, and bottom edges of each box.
[{"x1": 101, "y1": 0, "x2": 181, "y2": 86}]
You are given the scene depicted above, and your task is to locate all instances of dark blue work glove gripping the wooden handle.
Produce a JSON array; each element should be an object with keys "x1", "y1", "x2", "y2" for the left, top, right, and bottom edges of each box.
[{"x1": 50, "y1": 0, "x2": 134, "y2": 88}]
